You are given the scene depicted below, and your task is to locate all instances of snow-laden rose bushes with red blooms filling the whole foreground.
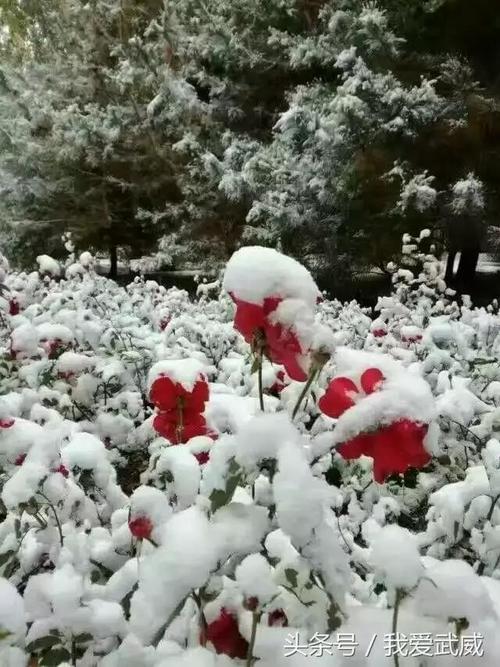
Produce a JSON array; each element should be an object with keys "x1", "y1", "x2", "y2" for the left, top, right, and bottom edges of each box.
[{"x1": 0, "y1": 241, "x2": 500, "y2": 667}]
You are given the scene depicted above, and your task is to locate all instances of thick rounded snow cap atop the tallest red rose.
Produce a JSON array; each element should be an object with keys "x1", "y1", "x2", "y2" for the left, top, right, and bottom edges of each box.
[{"x1": 223, "y1": 246, "x2": 320, "y2": 307}]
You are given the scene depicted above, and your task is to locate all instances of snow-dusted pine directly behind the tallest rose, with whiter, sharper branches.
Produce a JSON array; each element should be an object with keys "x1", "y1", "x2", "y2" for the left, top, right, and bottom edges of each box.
[{"x1": 167, "y1": 0, "x2": 457, "y2": 288}]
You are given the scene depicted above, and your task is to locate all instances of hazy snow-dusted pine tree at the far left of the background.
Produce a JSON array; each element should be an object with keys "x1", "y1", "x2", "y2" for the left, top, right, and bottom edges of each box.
[{"x1": 0, "y1": 0, "x2": 204, "y2": 272}]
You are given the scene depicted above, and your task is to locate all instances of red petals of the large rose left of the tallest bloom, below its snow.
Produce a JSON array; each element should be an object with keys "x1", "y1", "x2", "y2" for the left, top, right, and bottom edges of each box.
[{"x1": 150, "y1": 376, "x2": 208, "y2": 444}]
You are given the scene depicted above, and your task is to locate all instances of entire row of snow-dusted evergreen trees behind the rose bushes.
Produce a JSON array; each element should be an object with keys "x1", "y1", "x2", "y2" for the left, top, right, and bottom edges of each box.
[{"x1": 0, "y1": 0, "x2": 500, "y2": 290}]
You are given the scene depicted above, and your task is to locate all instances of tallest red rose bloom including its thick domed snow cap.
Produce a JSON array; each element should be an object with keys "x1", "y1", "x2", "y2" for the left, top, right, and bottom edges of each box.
[{"x1": 224, "y1": 246, "x2": 320, "y2": 382}]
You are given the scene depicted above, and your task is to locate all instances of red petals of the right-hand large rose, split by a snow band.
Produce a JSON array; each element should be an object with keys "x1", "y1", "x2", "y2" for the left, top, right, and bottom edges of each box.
[{"x1": 318, "y1": 368, "x2": 431, "y2": 483}]
